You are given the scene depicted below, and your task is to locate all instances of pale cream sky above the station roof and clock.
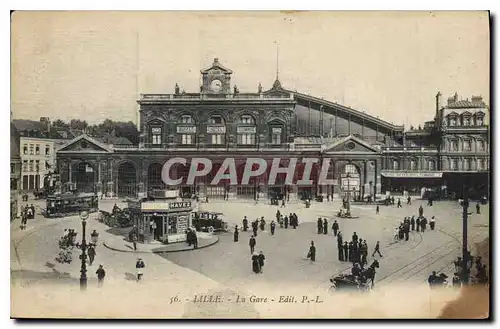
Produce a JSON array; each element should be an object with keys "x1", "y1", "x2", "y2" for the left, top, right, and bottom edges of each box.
[{"x1": 11, "y1": 11, "x2": 490, "y2": 127}]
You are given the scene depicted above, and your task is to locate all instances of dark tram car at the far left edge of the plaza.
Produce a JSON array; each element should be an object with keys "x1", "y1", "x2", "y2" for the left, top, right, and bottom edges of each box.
[{"x1": 44, "y1": 193, "x2": 99, "y2": 217}]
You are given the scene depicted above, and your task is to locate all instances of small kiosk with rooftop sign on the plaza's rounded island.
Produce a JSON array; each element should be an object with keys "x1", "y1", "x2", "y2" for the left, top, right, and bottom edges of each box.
[{"x1": 128, "y1": 190, "x2": 193, "y2": 244}]
